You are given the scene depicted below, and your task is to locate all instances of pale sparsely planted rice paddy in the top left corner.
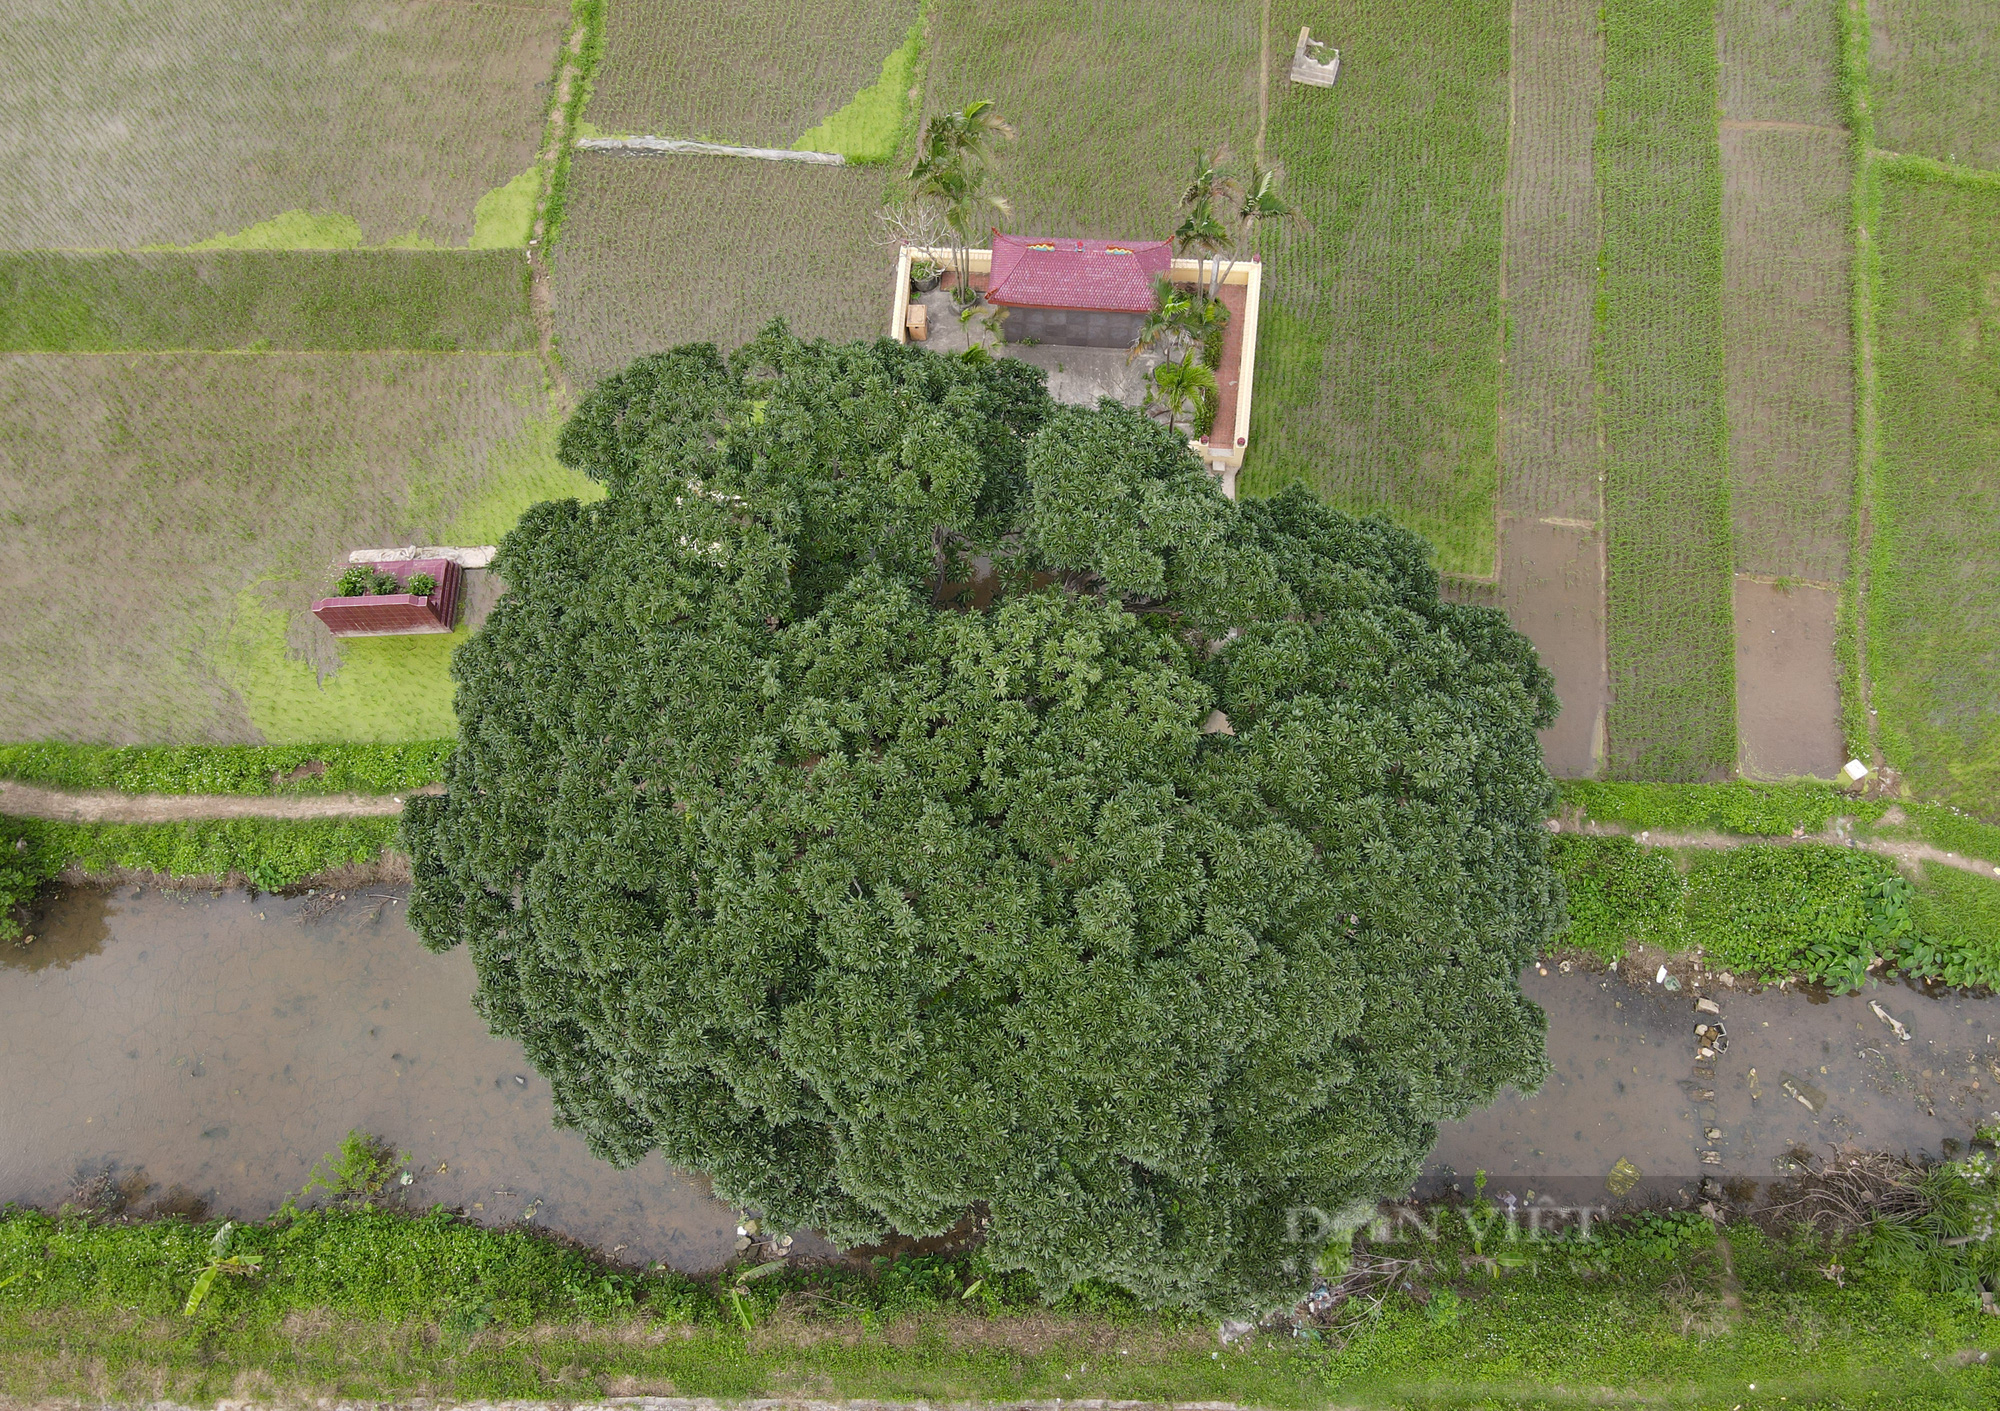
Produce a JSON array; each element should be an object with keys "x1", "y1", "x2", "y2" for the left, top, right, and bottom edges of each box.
[{"x1": 0, "y1": 0, "x2": 570, "y2": 250}]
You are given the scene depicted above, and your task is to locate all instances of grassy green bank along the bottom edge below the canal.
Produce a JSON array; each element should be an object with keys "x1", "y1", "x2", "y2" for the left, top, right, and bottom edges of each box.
[{"x1": 0, "y1": 1211, "x2": 2000, "y2": 1409}]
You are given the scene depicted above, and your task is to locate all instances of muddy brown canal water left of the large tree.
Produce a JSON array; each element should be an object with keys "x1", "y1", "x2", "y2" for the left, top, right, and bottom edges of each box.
[{"x1": 0, "y1": 887, "x2": 736, "y2": 1271}]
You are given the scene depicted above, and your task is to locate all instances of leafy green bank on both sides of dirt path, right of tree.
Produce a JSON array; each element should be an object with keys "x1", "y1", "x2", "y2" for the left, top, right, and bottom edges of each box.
[{"x1": 1554, "y1": 781, "x2": 2000, "y2": 987}]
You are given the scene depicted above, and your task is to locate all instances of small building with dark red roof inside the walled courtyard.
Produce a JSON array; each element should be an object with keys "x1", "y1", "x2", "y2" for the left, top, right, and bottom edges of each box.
[{"x1": 986, "y1": 230, "x2": 1174, "y2": 348}]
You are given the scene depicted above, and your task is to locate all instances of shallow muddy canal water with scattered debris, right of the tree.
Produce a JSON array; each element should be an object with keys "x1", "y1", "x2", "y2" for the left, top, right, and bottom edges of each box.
[{"x1": 1418, "y1": 965, "x2": 2000, "y2": 1205}]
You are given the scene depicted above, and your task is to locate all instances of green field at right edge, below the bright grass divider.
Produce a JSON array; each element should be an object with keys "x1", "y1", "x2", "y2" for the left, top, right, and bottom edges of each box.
[{"x1": 1866, "y1": 158, "x2": 2000, "y2": 817}]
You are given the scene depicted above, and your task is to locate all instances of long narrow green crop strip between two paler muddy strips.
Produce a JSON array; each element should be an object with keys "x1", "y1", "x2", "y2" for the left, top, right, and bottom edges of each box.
[{"x1": 1596, "y1": 0, "x2": 1736, "y2": 781}]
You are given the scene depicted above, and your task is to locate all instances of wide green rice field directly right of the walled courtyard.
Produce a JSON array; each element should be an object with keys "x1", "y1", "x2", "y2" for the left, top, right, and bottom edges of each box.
[{"x1": 1242, "y1": 0, "x2": 1508, "y2": 576}]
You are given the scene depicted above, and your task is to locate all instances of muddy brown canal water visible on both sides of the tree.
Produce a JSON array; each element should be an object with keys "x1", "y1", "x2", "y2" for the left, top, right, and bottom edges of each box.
[{"x1": 0, "y1": 887, "x2": 2000, "y2": 1271}]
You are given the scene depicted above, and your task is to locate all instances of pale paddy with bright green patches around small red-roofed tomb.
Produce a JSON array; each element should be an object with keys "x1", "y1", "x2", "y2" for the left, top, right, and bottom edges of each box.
[{"x1": 0, "y1": 354, "x2": 592, "y2": 743}]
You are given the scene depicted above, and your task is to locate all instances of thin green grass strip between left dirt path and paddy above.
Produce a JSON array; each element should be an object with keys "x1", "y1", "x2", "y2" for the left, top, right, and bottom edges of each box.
[{"x1": 0, "y1": 739, "x2": 452, "y2": 793}]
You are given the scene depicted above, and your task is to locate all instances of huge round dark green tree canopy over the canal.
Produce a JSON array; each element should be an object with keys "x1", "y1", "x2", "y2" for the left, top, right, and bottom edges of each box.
[{"x1": 408, "y1": 324, "x2": 1562, "y2": 1309}]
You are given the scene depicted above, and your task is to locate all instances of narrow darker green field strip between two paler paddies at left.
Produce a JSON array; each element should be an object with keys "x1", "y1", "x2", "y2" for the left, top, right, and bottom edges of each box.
[{"x1": 0, "y1": 250, "x2": 534, "y2": 352}]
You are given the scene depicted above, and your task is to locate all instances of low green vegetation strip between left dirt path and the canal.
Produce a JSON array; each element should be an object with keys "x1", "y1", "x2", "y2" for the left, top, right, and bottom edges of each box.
[{"x1": 0, "y1": 817, "x2": 398, "y2": 895}]
